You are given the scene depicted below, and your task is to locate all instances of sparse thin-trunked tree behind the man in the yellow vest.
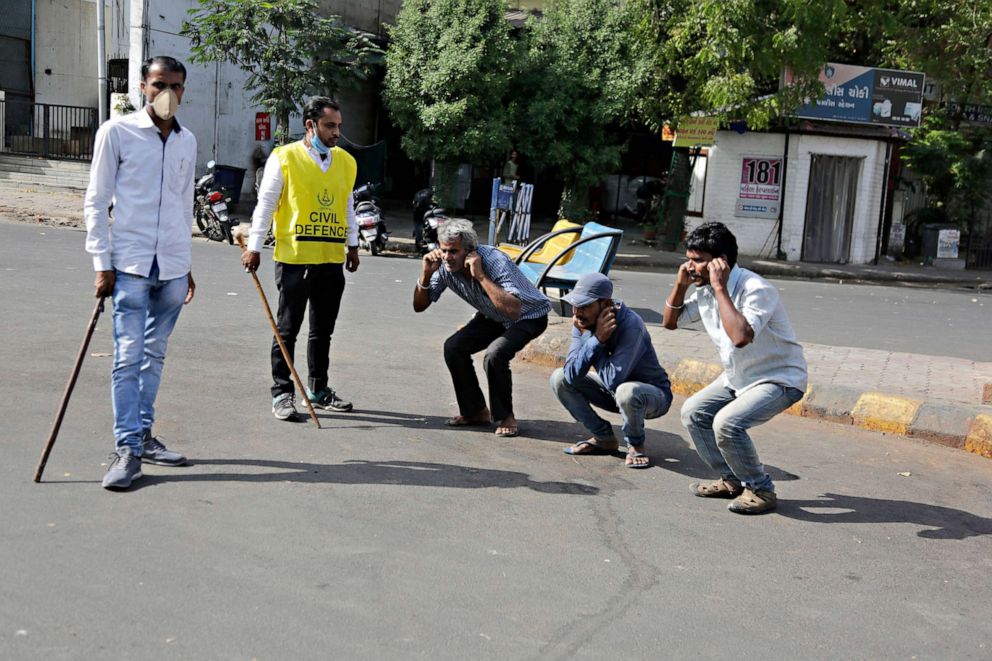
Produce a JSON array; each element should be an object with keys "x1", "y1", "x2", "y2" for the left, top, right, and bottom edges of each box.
[{"x1": 182, "y1": 0, "x2": 380, "y2": 143}]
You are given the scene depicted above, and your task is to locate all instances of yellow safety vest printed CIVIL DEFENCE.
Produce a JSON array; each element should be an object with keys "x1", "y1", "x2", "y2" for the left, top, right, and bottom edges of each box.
[{"x1": 272, "y1": 140, "x2": 358, "y2": 264}]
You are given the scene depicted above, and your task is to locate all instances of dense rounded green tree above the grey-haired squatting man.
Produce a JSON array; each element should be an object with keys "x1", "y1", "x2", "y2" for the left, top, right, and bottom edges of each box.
[{"x1": 383, "y1": 0, "x2": 517, "y2": 206}]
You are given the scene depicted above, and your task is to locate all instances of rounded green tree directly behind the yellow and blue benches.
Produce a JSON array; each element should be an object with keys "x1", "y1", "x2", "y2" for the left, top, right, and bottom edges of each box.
[{"x1": 513, "y1": 0, "x2": 639, "y2": 220}]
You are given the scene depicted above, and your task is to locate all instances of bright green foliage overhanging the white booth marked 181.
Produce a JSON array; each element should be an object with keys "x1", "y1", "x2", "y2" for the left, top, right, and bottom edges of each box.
[{"x1": 634, "y1": 0, "x2": 848, "y2": 128}]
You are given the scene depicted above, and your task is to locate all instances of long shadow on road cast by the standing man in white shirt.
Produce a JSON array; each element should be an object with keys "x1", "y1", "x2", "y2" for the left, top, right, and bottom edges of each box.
[{"x1": 132, "y1": 459, "x2": 599, "y2": 496}]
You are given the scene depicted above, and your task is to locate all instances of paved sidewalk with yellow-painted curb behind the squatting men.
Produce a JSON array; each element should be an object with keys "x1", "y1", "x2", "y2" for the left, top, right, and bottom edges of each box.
[{"x1": 521, "y1": 317, "x2": 992, "y2": 458}]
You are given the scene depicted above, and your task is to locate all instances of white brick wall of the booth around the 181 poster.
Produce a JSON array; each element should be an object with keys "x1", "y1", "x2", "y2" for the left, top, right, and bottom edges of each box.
[{"x1": 688, "y1": 131, "x2": 885, "y2": 264}]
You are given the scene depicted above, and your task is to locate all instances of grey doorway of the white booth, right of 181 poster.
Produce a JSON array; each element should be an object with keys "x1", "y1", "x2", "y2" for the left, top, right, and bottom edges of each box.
[{"x1": 801, "y1": 154, "x2": 863, "y2": 264}]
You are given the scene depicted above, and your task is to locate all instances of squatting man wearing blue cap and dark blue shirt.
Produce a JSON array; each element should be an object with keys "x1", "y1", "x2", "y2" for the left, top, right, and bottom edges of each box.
[{"x1": 551, "y1": 273, "x2": 672, "y2": 468}]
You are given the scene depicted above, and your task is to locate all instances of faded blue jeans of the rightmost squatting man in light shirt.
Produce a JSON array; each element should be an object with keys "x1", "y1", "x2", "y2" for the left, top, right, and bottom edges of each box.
[{"x1": 682, "y1": 377, "x2": 803, "y2": 491}]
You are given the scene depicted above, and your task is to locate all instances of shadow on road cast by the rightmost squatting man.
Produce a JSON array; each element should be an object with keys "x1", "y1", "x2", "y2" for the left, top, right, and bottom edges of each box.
[{"x1": 777, "y1": 493, "x2": 992, "y2": 539}]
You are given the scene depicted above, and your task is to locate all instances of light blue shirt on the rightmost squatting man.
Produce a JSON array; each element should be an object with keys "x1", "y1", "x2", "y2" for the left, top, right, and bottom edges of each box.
[{"x1": 679, "y1": 266, "x2": 807, "y2": 395}]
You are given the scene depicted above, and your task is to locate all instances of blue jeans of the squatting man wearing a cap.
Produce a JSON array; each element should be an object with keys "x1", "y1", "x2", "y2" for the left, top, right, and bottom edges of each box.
[{"x1": 551, "y1": 367, "x2": 672, "y2": 447}]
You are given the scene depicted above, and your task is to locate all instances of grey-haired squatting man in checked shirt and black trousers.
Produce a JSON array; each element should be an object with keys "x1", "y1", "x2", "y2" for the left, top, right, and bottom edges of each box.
[{"x1": 413, "y1": 219, "x2": 551, "y2": 437}]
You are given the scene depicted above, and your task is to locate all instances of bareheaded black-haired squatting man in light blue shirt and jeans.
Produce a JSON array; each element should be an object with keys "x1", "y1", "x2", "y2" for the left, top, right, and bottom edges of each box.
[{"x1": 663, "y1": 223, "x2": 807, "y2": 514}]
